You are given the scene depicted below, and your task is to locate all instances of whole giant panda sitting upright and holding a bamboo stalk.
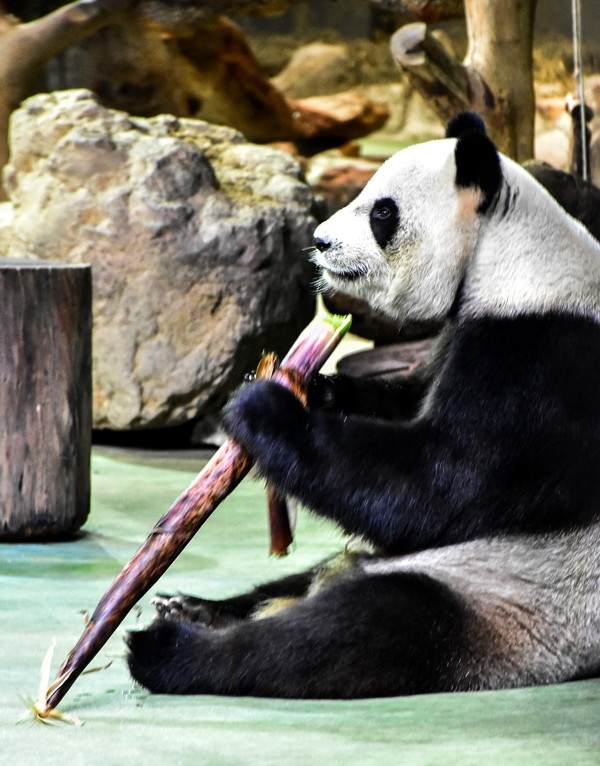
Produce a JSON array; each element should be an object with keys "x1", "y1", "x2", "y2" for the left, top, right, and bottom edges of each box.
[{"x1": 127, "y1": 113, "x2": 600, "y2": 698}]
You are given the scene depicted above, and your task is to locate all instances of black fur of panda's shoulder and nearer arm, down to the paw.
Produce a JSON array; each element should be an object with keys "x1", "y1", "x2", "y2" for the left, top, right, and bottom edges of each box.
[{"x1": 220, "y1": 316, "x2": 600, "y2": 553}]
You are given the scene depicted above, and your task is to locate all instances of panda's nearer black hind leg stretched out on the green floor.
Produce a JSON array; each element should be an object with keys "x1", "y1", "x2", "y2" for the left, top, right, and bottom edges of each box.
[{"x1": 127, "y1": 573, "x2": 468, "y2": 698}]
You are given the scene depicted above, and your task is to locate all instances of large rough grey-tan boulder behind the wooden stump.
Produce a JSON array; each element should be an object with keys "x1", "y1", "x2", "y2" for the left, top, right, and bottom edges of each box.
[{"x1": 0, "y1": 90, "x2": 315, "y2": 429}]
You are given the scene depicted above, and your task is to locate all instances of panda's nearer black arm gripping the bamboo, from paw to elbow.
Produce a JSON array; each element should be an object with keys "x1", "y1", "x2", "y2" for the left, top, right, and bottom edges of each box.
[{"x1": 224, "y1": 381, "x2": 480, "y2": 551}]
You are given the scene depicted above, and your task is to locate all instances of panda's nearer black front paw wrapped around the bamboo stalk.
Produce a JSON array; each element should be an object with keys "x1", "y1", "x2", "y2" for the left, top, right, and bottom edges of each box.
[{"x1": 223, "y1": 380, "x2": 308, "y2": 469}]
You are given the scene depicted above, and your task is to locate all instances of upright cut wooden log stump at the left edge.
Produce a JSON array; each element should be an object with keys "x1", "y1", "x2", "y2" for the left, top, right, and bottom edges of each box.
[{"x1": 0, "y1": 259, "x2": 92, "y2": 541}]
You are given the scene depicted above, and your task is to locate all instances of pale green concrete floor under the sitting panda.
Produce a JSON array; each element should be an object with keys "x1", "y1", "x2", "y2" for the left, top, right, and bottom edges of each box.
[{"x1": 0, "y1": 449, "x2": 600, "y2": 766}]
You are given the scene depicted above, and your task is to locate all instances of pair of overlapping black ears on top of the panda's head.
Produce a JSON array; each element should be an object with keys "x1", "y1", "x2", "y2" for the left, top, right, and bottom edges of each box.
[{"x1": 446, "y1": 112, "x2": 502, "y2": 213}]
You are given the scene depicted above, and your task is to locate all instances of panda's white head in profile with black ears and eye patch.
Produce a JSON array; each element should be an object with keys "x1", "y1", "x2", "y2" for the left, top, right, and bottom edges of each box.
[{"x1": 314, "y1": 112, "x2": 502, "y2": 324}]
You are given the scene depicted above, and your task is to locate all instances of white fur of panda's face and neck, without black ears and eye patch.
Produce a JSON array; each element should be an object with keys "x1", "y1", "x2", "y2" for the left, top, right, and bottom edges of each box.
[{"x1": 314, "y1": 139, "x2": 600, "y2": 324}]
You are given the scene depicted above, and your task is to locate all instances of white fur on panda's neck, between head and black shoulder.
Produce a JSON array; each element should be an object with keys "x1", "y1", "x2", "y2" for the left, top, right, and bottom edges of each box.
[{"x1": 464, "y1": 157, "x2": 600, "y2": 319}]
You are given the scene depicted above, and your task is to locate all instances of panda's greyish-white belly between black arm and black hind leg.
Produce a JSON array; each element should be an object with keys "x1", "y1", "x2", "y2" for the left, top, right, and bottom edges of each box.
[{"x1": 361, "y1": 523, "x2": 600, "y2": 688}]
